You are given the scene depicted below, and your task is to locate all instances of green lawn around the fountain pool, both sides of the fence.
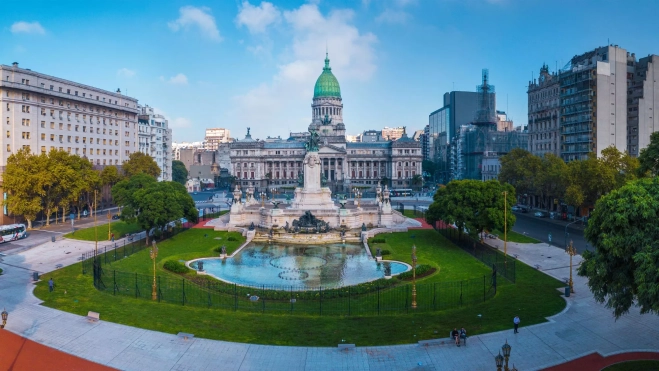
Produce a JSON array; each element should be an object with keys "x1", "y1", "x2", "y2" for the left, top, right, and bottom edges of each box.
[{"x1": 35, "y1": 229, "x2": 565, "y2": 346}]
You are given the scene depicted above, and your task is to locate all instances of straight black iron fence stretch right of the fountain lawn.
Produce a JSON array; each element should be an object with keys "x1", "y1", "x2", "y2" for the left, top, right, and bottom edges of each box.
[{"x1": 435, "y1": 226, "x2": 517, "y2": 283}]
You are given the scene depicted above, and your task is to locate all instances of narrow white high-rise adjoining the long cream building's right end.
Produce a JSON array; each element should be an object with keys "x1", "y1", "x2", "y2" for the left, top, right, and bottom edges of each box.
[{"x1": 138, "y1": 105, "x2": 172, "y2": 181}]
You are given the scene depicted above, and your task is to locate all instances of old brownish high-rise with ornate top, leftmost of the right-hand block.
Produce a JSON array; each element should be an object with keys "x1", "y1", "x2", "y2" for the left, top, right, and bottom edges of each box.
[{"x1": 527, "y1": 64, "x2": 561, "y2": 156}]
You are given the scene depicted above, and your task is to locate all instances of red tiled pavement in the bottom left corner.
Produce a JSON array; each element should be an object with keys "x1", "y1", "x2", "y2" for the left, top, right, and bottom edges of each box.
[{"x1": 0, "y1": 330, "x2": 115, "y2": 371}]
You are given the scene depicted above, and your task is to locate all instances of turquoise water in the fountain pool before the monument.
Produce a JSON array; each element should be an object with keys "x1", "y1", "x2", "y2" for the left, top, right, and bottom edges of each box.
[{"x1": 190, "y1": 243, "x2": 409, "y2": 290}]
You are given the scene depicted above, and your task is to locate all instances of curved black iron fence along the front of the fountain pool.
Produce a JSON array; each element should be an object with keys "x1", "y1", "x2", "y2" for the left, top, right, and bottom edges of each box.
[{"x1": 93, "y1": 259, "x2": 497, "y2": 316}]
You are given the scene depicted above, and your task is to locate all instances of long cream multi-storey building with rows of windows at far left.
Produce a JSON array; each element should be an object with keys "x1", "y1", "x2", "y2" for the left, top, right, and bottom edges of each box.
[{"x1": 0, "y1": 63, "x2": 138, "y2": 170}]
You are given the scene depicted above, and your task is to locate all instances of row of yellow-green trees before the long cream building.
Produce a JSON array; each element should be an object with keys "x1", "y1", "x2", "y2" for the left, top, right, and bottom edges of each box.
[{"x1": 2, "y1": 149, "x2": 160, "y2": 228}]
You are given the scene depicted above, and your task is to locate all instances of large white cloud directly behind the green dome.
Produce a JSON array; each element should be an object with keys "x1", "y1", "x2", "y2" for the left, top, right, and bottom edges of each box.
[{"x1": 229, "y1": 4, "x2": 377, "y2": 137}]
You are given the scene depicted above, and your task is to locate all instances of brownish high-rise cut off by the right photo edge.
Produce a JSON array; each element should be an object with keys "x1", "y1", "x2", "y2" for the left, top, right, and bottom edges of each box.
[{"x1": 627, "y1": 53, "x2": 659, "y2": 157}]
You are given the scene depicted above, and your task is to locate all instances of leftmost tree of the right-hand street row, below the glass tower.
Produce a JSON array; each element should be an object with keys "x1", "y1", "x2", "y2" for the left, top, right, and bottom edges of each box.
[{"x1": 499, "y1": 148, "x2": 542, "y2": 205}]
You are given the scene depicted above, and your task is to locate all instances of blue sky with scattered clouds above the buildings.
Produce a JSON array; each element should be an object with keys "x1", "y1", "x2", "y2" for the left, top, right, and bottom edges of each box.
[{"x1": 0, "y1": 0, "x2": 659, "y2": 141}]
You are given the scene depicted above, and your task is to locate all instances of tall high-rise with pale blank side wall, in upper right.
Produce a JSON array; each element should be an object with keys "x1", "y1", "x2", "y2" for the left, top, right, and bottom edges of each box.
[{"x1": 559, "y1": 45, "x2": 634, "y2": 161}]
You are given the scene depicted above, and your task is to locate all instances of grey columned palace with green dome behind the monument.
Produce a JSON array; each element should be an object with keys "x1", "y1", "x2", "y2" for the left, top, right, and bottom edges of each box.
[{"x1": 230, "y1": 54, "x2": 422, "y2": 194}]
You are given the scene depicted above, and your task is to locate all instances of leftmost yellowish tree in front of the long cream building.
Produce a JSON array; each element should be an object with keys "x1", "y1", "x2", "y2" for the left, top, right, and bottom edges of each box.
[{"x1": 2, "y1": 149, "x2": 47, "y2": 229}]
